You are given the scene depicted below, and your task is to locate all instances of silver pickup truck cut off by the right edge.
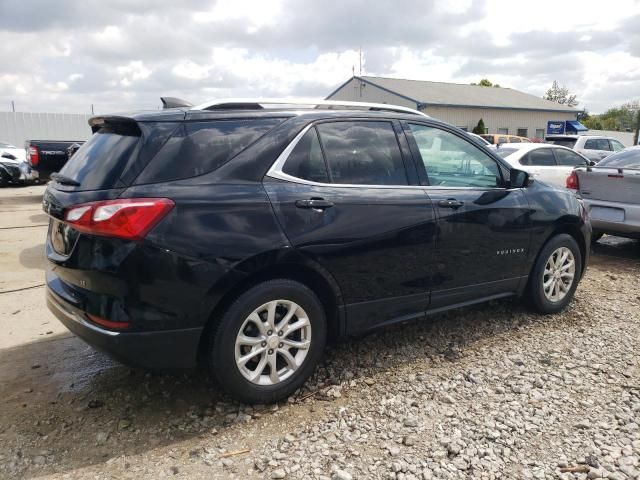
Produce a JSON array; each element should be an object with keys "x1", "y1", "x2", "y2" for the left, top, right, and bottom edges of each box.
[{"x1": 567, "y1": 146, "x2": 640, "y2": 241}]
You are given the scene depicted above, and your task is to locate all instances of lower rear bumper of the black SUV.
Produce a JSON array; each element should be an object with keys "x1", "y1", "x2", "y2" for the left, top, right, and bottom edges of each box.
[{"x1": 46, "y1": 285, "x2": 203, "y2": 369}]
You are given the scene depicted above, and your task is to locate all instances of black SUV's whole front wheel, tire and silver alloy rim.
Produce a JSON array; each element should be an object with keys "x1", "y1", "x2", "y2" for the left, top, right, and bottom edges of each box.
[{"x1": 528, "y1": 234, "x2": 582, "y2": 314}]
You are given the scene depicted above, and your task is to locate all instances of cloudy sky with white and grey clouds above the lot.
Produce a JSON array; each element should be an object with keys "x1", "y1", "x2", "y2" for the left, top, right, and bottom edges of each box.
[{"x1": 0, "y1": 0, "x2": 640, "y2": 112}]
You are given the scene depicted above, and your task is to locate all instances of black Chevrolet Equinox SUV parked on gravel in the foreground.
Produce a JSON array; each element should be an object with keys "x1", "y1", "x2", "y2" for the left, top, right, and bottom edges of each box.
[{"x1": 43, "y1": 102, "x2": 591, "y2": 403}]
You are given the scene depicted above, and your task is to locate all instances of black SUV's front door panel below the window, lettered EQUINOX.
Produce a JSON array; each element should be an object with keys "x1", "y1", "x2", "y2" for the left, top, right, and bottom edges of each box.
[{"x1": 427, "y1": 187, "x2": 531, "y2": 308}]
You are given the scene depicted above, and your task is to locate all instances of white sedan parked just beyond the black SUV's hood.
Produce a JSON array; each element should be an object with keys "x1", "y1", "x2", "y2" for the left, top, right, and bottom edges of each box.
[{"x1": 496, "y1": 143, "x2": 593, "y2": 188}]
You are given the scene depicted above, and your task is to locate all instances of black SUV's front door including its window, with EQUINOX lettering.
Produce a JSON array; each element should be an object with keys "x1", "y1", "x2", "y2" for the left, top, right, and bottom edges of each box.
[{"x1": 403, "y1": 122, "x2": 533, "y2": 309}]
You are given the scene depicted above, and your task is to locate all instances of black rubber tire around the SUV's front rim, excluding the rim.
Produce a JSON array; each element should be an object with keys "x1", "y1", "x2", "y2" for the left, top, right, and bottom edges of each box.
[{"x1": 529, "y1": 234, "x2": 582, "y2": 313}]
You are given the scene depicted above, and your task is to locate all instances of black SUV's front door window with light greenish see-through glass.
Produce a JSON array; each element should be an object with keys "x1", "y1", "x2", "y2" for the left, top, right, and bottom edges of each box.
[{"x1": 409, "y1": 123, "x2": 502, "y2": 188}]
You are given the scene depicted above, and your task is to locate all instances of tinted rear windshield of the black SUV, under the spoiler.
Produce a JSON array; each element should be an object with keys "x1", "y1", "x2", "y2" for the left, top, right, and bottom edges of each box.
[{"x1": 60, "y1": 123, "x2": 141, "y2": 190}]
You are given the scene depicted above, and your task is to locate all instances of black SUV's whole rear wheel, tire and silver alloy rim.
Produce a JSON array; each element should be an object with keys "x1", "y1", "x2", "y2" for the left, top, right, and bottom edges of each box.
[{"x1": 207, "y1": 279, "x2": 327, "y2": 404}]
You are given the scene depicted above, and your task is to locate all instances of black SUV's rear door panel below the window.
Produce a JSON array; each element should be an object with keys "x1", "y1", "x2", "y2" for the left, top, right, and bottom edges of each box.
[{"x1": 264, "y1": 177, "x2": 435, "y2": 327}]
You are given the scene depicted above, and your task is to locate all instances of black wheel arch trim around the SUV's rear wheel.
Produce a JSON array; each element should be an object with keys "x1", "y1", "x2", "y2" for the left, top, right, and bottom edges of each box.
[{"x1": 198, "y1": 250, "x2": 346, "y2": 360}]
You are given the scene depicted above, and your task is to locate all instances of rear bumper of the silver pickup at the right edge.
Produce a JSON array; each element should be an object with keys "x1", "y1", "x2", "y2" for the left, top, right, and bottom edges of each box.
[{"x1": 584, "y1": 198, "x2": 640, "y2": 238}]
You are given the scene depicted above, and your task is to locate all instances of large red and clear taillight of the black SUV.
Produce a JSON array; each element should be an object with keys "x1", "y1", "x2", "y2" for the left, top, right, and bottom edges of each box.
[{"x1": 64, "y1": 198, "x2": 175, "y2": 240}]
